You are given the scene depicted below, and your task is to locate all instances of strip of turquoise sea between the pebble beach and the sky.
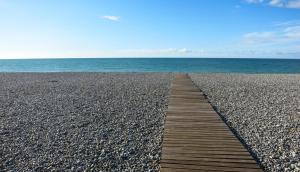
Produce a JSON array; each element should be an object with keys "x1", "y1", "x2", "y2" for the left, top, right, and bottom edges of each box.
[{"x1": 0, "y1": 58, "x2": 300, "y2": 73}]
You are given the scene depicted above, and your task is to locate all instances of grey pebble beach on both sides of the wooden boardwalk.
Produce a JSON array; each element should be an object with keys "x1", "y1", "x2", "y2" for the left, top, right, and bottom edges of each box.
[{"x1": 0, "y1": 73, "x2": 300, "y2": 171}]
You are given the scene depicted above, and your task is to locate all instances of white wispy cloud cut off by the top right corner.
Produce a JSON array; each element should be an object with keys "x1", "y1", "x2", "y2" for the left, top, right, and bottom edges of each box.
[{"x1": 245, "y1": 0, "x2": 300, "y2": 9}]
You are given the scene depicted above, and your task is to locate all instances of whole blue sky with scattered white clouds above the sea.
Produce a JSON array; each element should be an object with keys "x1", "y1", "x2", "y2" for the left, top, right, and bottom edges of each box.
[{"x1": 0, "y1": 0, "x2": 300, "y2": 59}]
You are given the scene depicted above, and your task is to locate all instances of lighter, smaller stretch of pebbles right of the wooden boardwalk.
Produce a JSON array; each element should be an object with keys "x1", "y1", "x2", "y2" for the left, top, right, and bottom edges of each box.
[{"x1": 190, "y1": 74, "x2": 300, "y2": 171}]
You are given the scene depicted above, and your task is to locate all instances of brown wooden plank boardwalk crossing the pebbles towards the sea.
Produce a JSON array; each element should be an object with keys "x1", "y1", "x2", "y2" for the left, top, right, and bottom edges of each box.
[{"x1": 160, "y1": 74, "x2": 262, "y2": 172}]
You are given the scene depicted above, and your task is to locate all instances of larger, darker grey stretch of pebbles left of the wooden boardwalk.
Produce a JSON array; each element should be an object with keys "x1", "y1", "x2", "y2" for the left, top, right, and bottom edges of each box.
[{"x1": 0, "y1": 73, "x2": 172, "y2": 172}]
